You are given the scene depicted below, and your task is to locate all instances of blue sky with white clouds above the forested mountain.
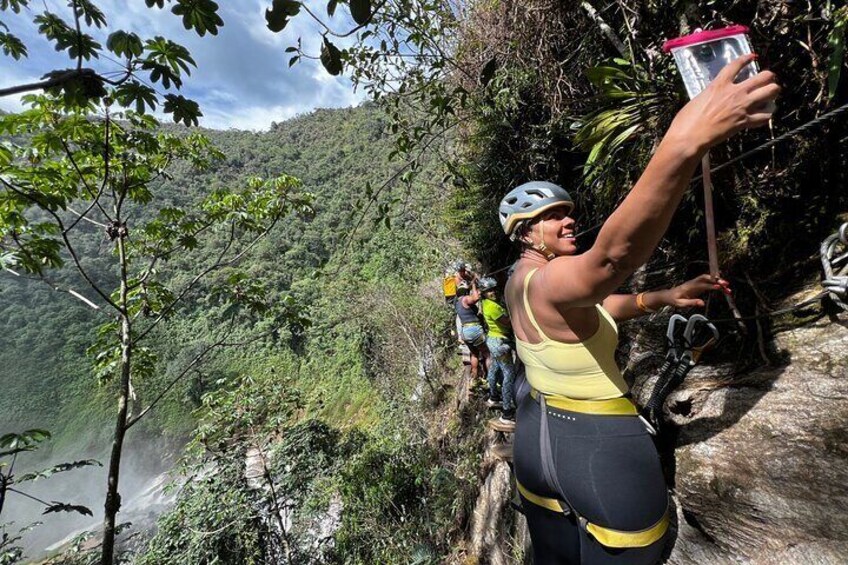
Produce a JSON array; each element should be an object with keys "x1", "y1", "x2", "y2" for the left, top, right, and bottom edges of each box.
[{"x1": 0, "y1": 0, "x2": 364, "y2": 130}]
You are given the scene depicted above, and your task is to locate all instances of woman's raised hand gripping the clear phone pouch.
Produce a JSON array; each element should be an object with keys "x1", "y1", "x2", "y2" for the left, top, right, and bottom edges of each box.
[{"x1": 669, "y1": 54, "x2": 780, "y2": 151}]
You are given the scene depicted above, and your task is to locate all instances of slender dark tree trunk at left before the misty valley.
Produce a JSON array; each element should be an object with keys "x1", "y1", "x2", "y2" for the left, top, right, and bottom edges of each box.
[{"x1": 100, "y1": 235, "x2": 132, "y2": 565}]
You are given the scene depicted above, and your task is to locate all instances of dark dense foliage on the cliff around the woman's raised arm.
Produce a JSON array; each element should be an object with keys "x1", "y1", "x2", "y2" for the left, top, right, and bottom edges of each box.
[{"x1": 454, "y1": 1, "x2": 846, "y2": 286}]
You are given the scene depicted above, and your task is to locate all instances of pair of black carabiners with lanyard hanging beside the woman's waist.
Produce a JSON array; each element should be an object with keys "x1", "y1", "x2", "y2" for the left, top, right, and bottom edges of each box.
[{"x1": 642, "y1": 314, "x2": 719, "y2": 428}]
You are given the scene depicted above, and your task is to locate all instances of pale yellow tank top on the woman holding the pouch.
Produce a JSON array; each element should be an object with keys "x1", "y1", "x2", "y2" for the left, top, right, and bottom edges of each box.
[{"x1": 515, "y1": 269, "x2": 628, "y2": 400}]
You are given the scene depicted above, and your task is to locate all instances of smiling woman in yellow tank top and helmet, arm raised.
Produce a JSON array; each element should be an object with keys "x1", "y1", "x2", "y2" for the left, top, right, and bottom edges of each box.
[{"x1": 499, "y1": 55, "x2": 780, "y2": 565}]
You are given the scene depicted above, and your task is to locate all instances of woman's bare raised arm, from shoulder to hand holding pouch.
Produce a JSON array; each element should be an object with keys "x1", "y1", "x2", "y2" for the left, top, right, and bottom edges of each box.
[{"x1": 537, "y1": 55, "x2": 780, "y2": 306}]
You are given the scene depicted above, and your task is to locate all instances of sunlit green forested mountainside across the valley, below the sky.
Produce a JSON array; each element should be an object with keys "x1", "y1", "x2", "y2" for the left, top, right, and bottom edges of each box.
[{"x1": 0, "y1": 104, "x2": 470, "y2": 562}]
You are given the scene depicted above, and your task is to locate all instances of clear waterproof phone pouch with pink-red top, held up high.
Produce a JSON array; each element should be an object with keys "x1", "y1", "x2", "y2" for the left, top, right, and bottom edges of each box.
[{"x1": 663, "y1": 25, "x2": 759, "y2": 98}]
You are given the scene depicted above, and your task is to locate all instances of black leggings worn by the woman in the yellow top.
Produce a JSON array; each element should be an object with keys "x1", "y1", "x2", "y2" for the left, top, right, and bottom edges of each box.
[{"x1": 514, "y1": 395, "x2": 668, "y2": 565}]
